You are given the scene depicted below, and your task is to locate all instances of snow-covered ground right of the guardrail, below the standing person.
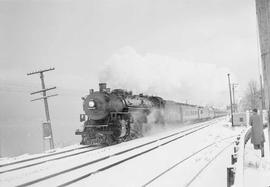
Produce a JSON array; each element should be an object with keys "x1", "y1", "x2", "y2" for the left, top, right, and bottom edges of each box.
[{"x1": 244, "y1": 129, "x2": 270, "y2": 187}]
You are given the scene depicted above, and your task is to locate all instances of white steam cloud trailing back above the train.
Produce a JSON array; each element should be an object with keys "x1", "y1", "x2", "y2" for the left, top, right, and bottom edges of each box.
[{"x1": 100, "y1": 47, "x2": 233, "y2": 107}]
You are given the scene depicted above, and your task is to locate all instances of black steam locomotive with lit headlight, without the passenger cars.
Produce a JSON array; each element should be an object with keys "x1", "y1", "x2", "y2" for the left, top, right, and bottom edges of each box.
[{"x1": 75, "y1": 83, "x2": 165, "y2": 145}]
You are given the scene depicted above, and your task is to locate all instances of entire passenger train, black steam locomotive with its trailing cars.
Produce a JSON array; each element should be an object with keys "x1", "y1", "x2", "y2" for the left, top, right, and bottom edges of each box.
[{"x1": 75, "y1": 83, "x2": 226, "y2": 145}]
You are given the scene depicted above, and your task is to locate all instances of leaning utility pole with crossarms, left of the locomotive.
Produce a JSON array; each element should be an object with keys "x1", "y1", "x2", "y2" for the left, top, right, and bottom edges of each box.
[{"x1": 27, "y1": 68, "x2": 58, "y2": 149}]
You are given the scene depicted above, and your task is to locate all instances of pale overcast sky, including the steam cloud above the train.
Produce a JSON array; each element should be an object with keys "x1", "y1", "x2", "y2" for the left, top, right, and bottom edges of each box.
[{"x1": 0, "y1": 0, "x2": 259, "y2": 156}]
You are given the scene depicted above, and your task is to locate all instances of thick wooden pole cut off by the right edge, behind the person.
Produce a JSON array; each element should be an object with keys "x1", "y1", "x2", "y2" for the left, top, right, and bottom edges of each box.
[{"x1": 255, "y1": 0, "x2": 270, "y2": 156}]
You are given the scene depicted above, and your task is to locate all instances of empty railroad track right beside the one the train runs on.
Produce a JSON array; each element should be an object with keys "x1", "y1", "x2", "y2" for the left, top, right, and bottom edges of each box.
[{"x1": 4, "y1": 120, "x2": 216, "y2": 186}]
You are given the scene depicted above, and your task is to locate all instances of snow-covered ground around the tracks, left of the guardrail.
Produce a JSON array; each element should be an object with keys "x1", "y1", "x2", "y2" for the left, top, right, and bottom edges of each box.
[{"x1": 0, "y1": 119, "x2": 246, "y2": 186}]
